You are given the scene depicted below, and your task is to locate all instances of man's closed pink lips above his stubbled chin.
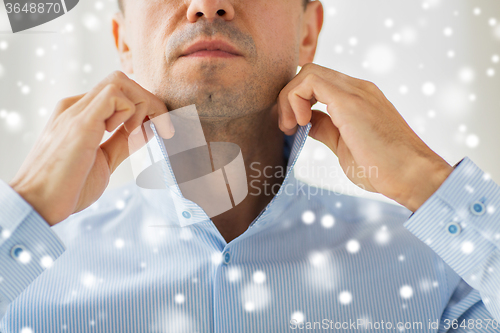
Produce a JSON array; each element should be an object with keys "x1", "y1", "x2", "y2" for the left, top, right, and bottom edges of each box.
[{"x1": 180, "y1": 40, "x2": 242, "y2": 58}]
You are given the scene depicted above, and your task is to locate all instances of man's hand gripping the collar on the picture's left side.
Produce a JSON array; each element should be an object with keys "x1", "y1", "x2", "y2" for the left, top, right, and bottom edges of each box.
[{"x1": 9, "y1": 71, "x2": 174, "y2": 226}]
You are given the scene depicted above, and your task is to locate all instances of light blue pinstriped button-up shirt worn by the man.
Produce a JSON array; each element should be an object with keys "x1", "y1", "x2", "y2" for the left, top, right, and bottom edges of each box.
[{"x1": 0, "y1": 124, "x2": 500, "y2": 333}]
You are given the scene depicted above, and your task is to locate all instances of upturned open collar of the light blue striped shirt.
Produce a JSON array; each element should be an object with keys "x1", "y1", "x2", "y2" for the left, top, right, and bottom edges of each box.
[{"x1": 140, "y1": 123, "x2": 311, "y2": 226}]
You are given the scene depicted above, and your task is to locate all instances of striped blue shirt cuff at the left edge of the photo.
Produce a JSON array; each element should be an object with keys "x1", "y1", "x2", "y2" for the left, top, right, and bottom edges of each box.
[{"x1": 0, "y1": 180, "x2": 66, "y2": 319}]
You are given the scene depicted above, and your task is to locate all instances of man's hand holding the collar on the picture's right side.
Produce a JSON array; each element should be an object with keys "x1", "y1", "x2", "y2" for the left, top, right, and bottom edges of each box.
[{"x1": 278, "y1": 64, "x2": 453, "y2": 212}]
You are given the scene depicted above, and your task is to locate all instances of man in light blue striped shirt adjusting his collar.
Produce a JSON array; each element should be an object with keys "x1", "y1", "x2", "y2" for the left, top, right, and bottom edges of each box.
[{"x1": 0, "y1": 0, "x2": 500, "y2": 332}]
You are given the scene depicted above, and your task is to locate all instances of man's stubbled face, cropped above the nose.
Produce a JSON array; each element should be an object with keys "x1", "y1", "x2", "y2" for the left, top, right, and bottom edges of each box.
[{"x1": 115, "y1": 0, "x2": 318, "y2": 121}]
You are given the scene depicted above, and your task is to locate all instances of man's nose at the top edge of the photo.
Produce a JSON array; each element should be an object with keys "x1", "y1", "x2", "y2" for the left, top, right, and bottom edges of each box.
[{"x1": 187, "y1": 0, "x2": 234, "y2": 23}]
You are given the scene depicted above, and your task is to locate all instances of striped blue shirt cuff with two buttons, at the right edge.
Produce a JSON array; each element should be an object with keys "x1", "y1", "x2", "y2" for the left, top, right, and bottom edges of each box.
[{"x1": 403, "y1": 157, "x2": 500, "y2": 322}]
